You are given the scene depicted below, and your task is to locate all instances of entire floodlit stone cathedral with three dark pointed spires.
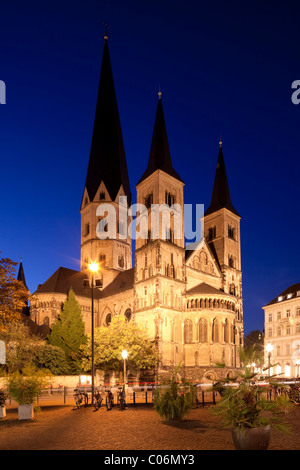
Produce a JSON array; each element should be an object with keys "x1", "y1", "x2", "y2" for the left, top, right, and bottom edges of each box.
[{"x1": 30, "y1": 35, "x2": 243, "y2": 381}]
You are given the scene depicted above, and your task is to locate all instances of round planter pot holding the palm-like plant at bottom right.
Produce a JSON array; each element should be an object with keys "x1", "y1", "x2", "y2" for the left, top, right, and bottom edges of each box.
[{"x1": 232, "y1": 426, "x2": 270, "y2": 450}]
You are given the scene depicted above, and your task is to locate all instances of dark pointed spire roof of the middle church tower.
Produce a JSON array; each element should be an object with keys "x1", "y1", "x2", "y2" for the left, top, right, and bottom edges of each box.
[{"x1": 138, "y1": 91, "x2": 182, "y2": 184}]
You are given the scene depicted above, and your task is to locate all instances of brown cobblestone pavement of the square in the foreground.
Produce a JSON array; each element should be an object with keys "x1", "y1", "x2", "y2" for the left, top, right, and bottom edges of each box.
[{"x1": 0, "y1": 405, "x2": 300, "y2": 450}]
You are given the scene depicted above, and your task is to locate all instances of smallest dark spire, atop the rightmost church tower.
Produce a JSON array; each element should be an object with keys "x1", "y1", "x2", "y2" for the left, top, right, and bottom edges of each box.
[{"x1": 205, "y1": 142, "x2": 239, "y2": 216}]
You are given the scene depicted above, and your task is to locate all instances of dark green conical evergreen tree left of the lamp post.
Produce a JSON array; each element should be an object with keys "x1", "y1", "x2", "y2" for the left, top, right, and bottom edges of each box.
[{"x1": 48, "y1": 289, "x2": 87, "y2": 374}]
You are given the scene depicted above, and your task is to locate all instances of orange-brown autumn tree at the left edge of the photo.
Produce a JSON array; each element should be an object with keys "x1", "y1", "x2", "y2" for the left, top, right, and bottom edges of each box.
[{"x1": 0, "y1": 258, "x2": 29, "y2": 331}]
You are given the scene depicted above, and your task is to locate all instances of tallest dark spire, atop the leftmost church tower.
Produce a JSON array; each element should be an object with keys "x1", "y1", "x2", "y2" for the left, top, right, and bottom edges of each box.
[{"x1": 85, "y1": 35, "x2": 131, "y2": 204}]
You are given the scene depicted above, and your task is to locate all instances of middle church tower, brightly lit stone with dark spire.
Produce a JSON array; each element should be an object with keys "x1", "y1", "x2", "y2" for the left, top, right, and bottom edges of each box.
[{"x1": 134, "y1": 93, "x2": 186, "y2": 370}]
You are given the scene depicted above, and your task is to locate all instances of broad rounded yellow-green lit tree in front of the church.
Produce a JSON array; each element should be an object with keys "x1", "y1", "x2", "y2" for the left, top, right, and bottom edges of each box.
[{"x1": 82, "y1": 315, "x2": 158, "y2": 371}]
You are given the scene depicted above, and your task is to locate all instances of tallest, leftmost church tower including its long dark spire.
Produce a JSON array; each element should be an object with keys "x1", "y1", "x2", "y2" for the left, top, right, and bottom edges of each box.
[{"x1": 80, "y1": 33, "x2": 132, "y2": 287}]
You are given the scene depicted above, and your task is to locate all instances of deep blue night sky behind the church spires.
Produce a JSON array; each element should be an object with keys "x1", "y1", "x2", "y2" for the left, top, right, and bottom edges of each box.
[{"x1": 0, "y1": 0, "x2": 300, "y2": 334}]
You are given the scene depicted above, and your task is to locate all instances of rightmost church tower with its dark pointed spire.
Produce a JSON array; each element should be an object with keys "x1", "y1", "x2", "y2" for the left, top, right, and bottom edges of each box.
[{"x1": 204, "y1": 142, "x2": 243, "y2": 338}]
